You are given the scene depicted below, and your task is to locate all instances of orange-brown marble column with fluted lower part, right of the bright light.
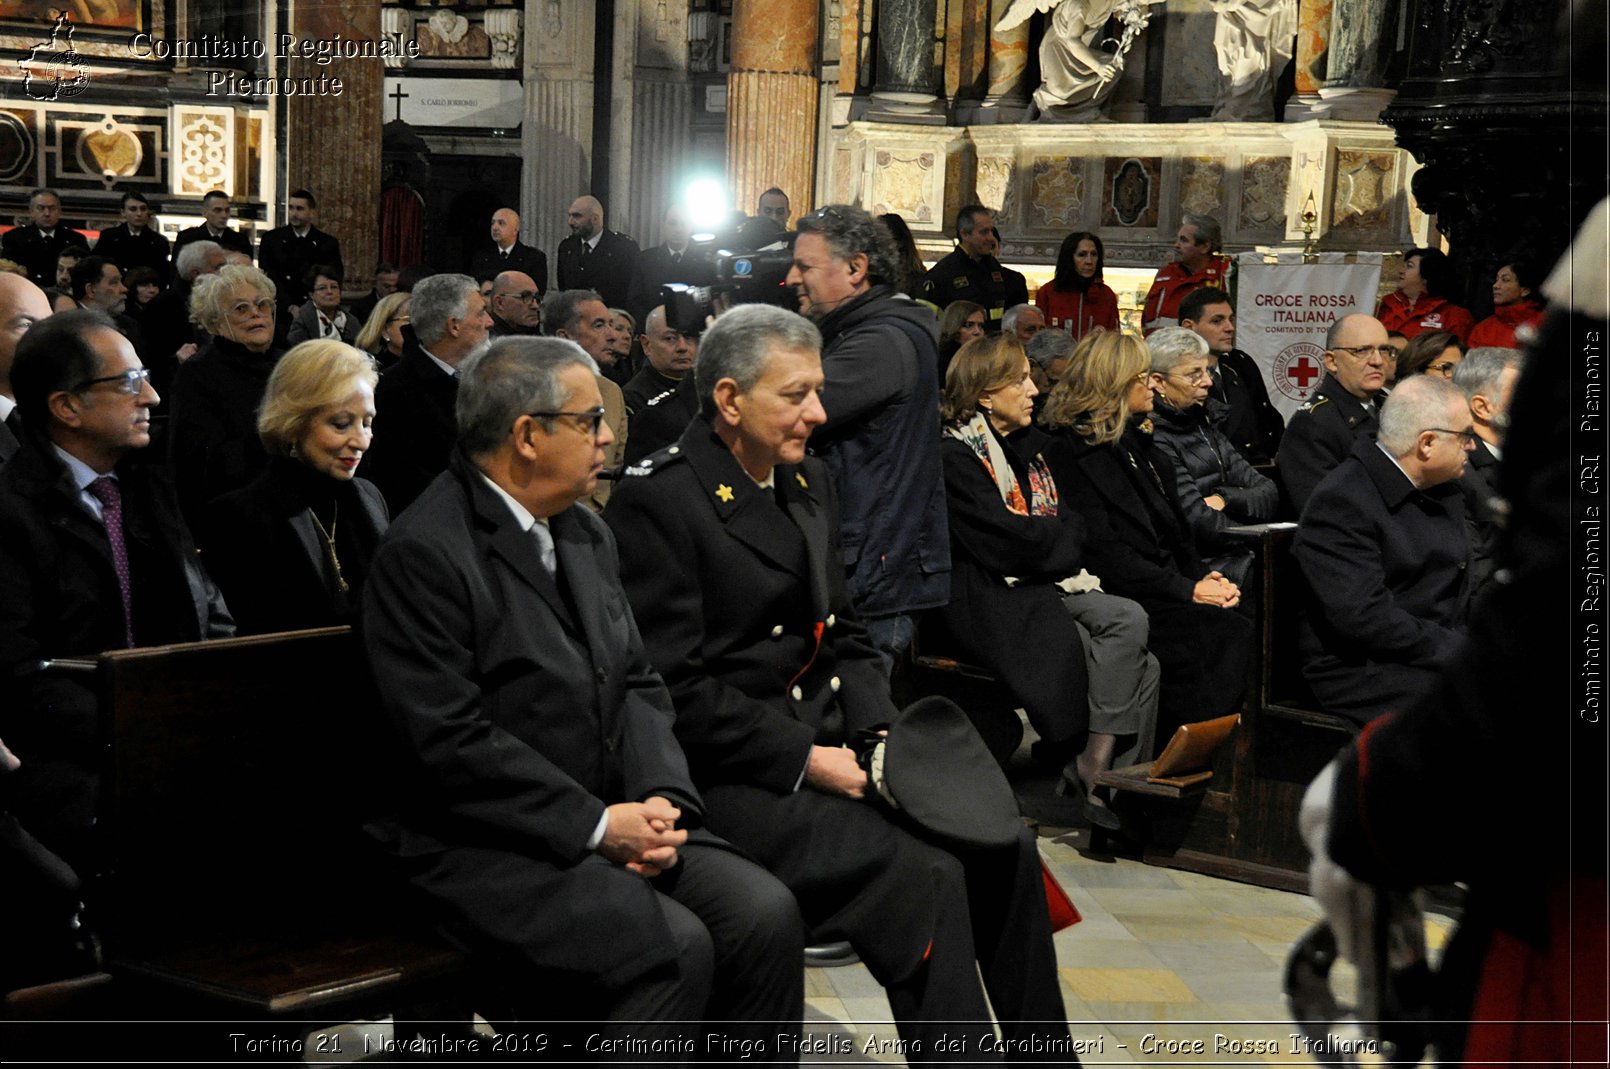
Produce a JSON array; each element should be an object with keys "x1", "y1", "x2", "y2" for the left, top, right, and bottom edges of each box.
[{"x1": 726, "y1": 0, "x2": 821, "y2": 217}]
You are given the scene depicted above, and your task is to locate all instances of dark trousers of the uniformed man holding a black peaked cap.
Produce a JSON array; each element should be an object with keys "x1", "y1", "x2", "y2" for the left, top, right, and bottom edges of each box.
[{"x1": 704, "y1": 786, "x2": 1069, "y2": 1066}]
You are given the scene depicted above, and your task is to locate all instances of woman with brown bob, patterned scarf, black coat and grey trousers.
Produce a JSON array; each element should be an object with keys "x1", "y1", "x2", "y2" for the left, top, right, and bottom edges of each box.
[{"x1": 940, "y1": 332, "x2": 1158, "y2": 829}]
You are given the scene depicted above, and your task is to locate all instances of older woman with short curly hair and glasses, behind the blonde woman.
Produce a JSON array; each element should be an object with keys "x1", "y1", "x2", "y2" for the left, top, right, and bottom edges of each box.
[{"x1": 167, "y1": 264, "x2": 280, "y2": 533}]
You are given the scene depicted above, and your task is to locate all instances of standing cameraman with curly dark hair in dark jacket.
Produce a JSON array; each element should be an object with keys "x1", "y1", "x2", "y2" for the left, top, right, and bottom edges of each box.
[{"x1": 787, "y1": 204, "x2": 950, "y2": 667}]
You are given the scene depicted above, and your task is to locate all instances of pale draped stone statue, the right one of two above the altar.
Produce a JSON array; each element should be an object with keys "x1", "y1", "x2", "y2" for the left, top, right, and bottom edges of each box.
[{"x1": 1212, "y1": 0, "x2": 1298, "y2": 122}]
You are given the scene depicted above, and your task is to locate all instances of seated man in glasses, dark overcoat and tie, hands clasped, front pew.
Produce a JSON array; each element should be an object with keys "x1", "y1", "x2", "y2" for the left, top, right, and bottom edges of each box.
[{"x1": 364, "y1": 339, "x2": 803, "y2": 1055}]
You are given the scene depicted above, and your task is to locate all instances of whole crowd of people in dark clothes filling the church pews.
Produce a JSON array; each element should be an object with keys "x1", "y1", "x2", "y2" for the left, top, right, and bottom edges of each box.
[{"x1": 0, "y1": 185, "x2": 1530, "y2": 1038}]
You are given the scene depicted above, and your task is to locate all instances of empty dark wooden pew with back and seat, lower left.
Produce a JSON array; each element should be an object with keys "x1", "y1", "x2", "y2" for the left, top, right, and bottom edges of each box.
[{"x1": 90, "y1": 628, "x2": 465, "y2": 1037}]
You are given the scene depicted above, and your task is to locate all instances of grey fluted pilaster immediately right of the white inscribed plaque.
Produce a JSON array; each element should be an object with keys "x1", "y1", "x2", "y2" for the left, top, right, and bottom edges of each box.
[{"x1": 520, "y1": 3, "x2": 602, "y2": 257}]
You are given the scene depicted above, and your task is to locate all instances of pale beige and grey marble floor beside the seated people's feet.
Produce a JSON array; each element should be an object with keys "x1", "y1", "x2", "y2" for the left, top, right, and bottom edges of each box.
[{"x1": 308, "y1": 829, "x2": 1451, "y2": 1066}]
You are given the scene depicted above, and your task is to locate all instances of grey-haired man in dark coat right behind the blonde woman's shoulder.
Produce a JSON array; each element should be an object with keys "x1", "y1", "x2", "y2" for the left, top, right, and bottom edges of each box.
[{"x1": 359, "y1": 275, "x2": 493, "y2": 515}]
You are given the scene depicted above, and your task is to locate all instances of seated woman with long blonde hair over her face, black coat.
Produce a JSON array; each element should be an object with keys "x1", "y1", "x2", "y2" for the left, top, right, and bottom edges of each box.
[{"x1": 1040, "y1": 332, "x2": 1253, "y2": 737}]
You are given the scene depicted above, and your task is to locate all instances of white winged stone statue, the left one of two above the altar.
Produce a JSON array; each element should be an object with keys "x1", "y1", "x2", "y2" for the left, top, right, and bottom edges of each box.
[{"x1": 995, "y1": 0, "x2": 1162, "y2": 122}]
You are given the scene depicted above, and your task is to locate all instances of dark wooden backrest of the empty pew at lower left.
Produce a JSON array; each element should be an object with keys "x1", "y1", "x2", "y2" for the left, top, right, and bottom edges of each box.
[{"x1": 95, "y1": 628, "x2": 396, "y2": 937}]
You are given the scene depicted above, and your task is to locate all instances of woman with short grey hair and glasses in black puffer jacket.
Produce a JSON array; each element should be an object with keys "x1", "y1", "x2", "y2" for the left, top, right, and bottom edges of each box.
[{"x1": 1146, "y1": 327, "x2": 1280, "y2": 588}]
